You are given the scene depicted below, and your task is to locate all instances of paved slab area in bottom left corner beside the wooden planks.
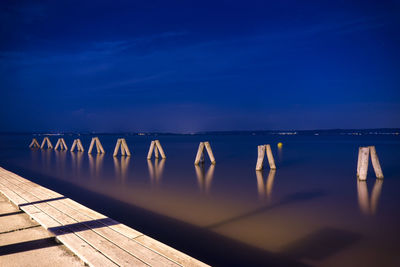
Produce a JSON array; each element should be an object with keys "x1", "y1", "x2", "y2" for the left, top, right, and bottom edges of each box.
[{"x1": 0, "y1": 194, "x2": 83, "y2": 267}]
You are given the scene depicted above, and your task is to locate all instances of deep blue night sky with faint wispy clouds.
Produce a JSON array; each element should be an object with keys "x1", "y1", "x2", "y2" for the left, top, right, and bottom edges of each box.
[{"x1": 0, "y1": 0, "x2": 400, "y2": 132}]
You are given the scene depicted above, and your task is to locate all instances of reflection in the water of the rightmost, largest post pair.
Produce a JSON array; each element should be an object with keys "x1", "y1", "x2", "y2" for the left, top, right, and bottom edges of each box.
[{"x1": 357, "y1": 179, "x2": 383, "y2": 215}]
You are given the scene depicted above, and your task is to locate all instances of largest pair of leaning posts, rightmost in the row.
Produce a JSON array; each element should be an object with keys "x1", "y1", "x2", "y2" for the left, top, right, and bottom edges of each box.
[{"x1": 357, "y1": 146, "x2": 383, "y2": 181}]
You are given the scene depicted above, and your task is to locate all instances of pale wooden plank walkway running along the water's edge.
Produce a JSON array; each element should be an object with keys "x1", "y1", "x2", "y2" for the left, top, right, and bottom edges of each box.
[{"x1": 0, "y1": 167, "x2": 207, "y2": 266}]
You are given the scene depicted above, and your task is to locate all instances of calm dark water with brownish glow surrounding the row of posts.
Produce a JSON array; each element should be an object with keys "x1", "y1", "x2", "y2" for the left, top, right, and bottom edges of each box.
[{"x1": 0, "y1": 134, "x2": 400, "y2": 266}]
